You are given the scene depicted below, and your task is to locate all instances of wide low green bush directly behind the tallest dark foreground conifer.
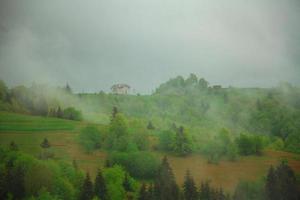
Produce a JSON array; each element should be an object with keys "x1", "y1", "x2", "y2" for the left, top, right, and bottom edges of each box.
[{"x1": 109, "y1": 152, "x2": 159, "y2": 179}]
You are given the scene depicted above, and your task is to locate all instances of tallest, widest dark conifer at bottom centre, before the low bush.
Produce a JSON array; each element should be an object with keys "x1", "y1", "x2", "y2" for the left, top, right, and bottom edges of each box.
[{"x1": 154, "y1": 156, "x2": 179, "y2": 200}]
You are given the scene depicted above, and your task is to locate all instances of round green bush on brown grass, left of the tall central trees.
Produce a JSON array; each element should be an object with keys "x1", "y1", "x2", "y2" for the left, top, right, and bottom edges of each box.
[{"x1": 78, "y1": 126, "x2": 102, "y2": 153}]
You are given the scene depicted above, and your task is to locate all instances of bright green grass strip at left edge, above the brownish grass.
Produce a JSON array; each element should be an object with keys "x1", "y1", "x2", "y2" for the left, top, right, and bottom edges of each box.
[{"x1": 0, "y1": 112, "x2": 79, "y2": 132}]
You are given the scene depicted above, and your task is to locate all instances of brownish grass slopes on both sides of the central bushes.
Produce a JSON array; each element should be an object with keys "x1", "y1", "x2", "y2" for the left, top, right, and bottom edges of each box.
[{"x1": 0, "y1": 131, "x2": 300, "y2": 192}]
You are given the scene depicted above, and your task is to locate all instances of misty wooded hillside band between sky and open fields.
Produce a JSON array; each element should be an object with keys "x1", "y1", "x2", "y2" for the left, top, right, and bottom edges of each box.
[{"x1": 0, "y1": 74, "x2": 300, "y2": 153}]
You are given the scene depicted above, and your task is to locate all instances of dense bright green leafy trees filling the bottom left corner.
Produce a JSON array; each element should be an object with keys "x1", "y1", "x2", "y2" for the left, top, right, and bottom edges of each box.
[{"x1": 0, "y1": 147, "x2": 83, "y2": 200}]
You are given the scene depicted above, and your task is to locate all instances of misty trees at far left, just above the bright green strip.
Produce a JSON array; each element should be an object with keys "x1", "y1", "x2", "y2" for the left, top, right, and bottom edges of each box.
[{"x1": 0, "y1": 80, "x2": 82, "y2": 120}]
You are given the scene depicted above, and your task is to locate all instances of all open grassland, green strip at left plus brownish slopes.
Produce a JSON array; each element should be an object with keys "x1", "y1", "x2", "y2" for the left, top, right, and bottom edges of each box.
[{"x1": 0, "y1": 112, "x2": 300, "y2": 192}]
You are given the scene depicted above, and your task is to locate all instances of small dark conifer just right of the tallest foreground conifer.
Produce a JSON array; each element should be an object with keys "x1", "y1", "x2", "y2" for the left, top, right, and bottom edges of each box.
[{"x1": 183, "y1": 171, "x2": 198, "y2": 200}]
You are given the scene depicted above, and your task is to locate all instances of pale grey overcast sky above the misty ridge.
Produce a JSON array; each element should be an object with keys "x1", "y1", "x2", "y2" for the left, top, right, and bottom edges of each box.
[{"x1": 0, "y1": 0, "x2": 300, "y2": 93}]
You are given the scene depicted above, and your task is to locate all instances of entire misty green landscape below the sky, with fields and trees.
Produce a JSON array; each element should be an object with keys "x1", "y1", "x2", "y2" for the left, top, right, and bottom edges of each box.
[{"x1": 0, "y1": 74, "x2": 300, "y2": 200}]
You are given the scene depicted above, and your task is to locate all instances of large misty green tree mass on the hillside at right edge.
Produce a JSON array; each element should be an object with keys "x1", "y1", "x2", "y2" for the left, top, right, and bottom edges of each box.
[{"x1": 250, "y1": 92, "x2": 300, "y2": 153}]
